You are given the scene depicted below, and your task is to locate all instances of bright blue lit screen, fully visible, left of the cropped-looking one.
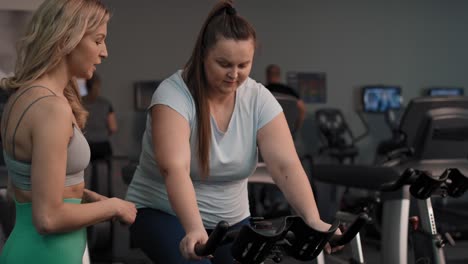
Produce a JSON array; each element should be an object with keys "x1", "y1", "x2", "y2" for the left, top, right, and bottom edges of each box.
[{"x1": 362, "y1": 85, "x2": 403, "y2": 113}]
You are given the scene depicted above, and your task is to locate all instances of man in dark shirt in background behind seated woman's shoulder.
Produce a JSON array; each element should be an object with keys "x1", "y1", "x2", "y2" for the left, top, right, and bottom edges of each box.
[{"x1": 265, "y1": 64, "x2": 306, "y2": 131}]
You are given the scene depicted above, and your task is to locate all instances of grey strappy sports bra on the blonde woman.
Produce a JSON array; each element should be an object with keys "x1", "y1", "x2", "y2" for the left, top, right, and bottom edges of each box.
[{"x1": 3, "y1": 86, "x2": 91, "y2": 191}]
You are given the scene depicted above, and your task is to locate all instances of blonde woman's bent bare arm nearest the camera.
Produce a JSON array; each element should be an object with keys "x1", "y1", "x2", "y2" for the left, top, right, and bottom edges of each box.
[{"x1": 31, "y1": 97, "x2": 136, "y2": 234}]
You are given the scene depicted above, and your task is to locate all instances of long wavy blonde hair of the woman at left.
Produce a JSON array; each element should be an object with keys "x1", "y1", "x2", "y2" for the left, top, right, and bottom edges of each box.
[{"x1": 0, "y1": 0, "x2": 110, "y2": 128}]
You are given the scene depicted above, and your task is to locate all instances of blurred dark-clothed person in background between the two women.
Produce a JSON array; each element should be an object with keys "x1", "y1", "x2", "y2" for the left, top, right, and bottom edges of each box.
[{"x1": 83, "y1": 74, "x2": 117, "y2": 195}]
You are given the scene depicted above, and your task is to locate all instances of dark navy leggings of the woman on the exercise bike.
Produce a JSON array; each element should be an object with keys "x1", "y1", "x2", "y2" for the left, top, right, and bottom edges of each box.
[{"x1": 130, "y1": 208, "x2": 249, "y2": 264}]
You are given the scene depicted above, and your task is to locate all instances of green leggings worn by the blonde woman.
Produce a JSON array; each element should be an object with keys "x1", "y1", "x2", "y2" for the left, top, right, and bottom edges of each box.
[{"x1": 0, "y1": 199, "x2": 86, "y2": 264}]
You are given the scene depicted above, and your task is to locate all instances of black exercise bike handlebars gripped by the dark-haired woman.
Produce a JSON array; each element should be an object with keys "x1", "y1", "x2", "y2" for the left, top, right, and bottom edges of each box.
[{"x1": 195, "y1": 214, "x2": 368, "y2": 264}]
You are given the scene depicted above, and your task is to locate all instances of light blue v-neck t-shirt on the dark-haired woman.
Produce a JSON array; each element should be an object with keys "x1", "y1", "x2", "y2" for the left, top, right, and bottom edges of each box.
[{"x1": 127, "y1": 71, "x2": 282, "y2": 228}]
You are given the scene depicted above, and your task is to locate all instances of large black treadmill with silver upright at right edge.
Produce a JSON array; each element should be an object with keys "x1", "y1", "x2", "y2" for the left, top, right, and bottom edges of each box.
[{"x1": 312, "y1": 97, "x2": 468, "y2": 264}]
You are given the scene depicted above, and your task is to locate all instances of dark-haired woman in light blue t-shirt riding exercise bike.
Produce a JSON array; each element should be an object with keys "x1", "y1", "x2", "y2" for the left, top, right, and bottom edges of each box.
[{"x1": 127, "y1": 1, "x2": 342, "y2": 263}]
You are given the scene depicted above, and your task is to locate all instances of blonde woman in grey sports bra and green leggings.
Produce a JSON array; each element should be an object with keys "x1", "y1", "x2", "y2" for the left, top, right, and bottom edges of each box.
[{"x1": 0, "y1": 0, "x2": 136, "y2": 264}]
